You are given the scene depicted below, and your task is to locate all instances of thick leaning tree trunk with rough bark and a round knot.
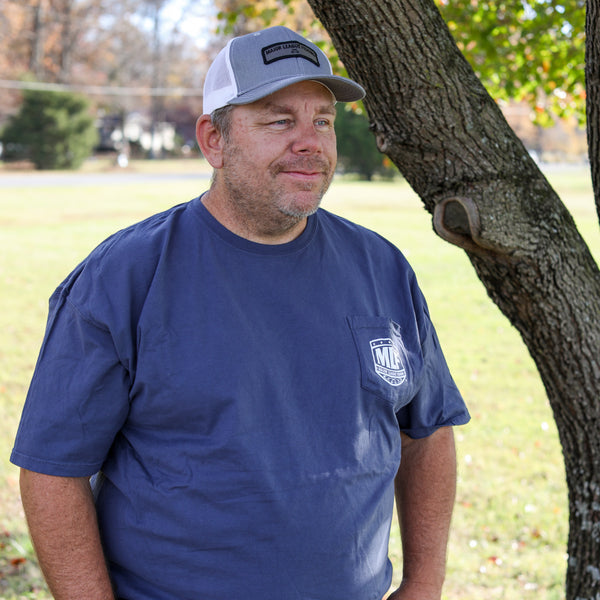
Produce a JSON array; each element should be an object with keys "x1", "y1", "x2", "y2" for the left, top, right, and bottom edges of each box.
[{"x1": 308, "y1": 0, "x2": 600, "y2": 600}]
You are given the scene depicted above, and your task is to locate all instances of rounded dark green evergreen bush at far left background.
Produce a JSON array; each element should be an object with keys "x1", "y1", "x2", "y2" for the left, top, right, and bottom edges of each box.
[{"x1": 1, "y1": 90, "x2": 98, "y2": 169}]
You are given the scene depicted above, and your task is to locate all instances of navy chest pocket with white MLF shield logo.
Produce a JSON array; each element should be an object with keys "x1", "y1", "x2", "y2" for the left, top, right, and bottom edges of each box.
[{"x1": 347, "y1": 316, "x2": 423, "y2": 412}]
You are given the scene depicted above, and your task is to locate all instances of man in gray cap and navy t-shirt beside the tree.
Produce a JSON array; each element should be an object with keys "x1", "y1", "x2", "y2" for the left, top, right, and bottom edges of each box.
[{"x1": 12, "y1": 27, "x2": 469, "y2": 600}]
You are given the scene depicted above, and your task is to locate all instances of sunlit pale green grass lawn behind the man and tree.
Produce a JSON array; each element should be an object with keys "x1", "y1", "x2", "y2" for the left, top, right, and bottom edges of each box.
[{"x1": 0, "y1": 161, "x2": 600, "y2": 600}]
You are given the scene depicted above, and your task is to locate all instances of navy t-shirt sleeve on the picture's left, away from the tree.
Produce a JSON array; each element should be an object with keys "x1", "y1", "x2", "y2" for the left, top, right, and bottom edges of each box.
[{"x1": 11, "y1": 287, "x2": 129, "y2": 477}]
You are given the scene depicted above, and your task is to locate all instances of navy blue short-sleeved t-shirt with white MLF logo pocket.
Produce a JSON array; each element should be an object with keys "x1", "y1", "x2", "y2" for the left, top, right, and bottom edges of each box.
[{"x1": 11, "y1": 198, "x2": 469, "y2": 600}]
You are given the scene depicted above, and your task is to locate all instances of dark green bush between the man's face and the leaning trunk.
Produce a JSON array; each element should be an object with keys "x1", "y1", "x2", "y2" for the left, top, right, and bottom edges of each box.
[{"x1": 335, "y1": 104, "x2": 398, "y2": 180}]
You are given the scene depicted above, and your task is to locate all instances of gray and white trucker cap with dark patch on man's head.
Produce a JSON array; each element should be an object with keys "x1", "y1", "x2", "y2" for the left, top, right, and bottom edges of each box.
[{"x1": 203, "y1": 26, "x2": 365, "y2": 115}]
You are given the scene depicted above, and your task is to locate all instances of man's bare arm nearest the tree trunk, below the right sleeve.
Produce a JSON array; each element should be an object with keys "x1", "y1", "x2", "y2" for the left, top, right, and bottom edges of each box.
[{"x1": 389, "y1": 427, "x2": 456, "y2": 600}]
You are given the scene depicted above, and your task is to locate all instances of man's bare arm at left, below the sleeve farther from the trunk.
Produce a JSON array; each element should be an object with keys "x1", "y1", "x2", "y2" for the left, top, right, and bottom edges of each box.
[{"x1": 21, "y1": 469, "x2": 114, "y2": 600}]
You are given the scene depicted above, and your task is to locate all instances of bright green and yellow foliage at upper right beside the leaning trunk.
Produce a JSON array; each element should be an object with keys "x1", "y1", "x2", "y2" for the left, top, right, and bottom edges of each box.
[{"x1": 435, "y1": 0, "x2": 586, "y2": 125}]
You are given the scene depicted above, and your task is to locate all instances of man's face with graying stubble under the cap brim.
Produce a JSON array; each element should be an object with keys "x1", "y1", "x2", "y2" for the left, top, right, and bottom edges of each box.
[{"x1": 219, "y1": 81, "x2": 337, "y2": 239}]
